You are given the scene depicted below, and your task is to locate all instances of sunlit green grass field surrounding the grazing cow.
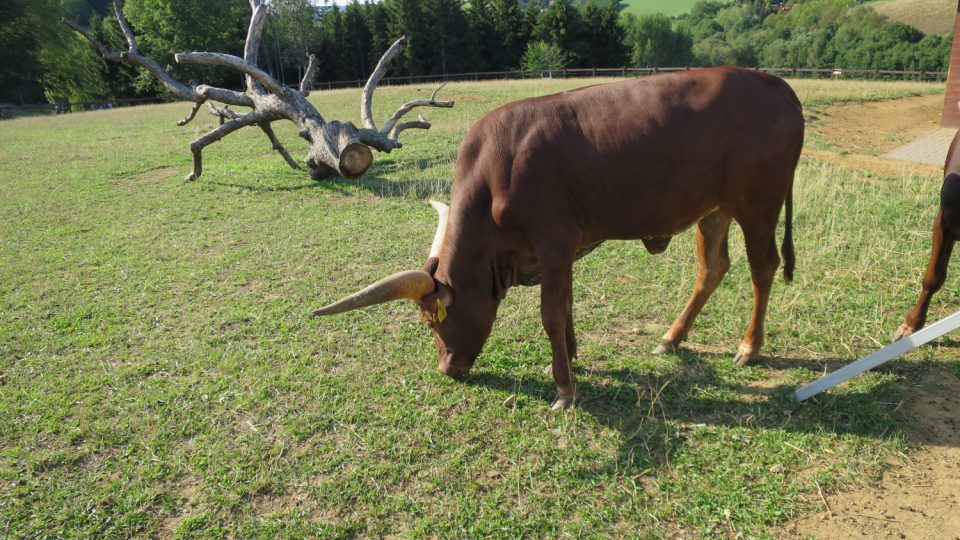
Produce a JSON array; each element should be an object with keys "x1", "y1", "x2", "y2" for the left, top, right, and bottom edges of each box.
[{"x1": 0, "y1": 75, "x2": 960, "y2": 538}]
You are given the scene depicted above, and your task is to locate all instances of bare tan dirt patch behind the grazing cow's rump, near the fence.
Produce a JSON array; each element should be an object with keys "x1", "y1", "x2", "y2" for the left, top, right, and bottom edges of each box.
[{"x1": 804, "y1": 95, "x2": 943, "y2": 176}]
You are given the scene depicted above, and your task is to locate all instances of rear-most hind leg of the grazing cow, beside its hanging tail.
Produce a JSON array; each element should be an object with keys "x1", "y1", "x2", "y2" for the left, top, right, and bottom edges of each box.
[{"x1": 733, "y1": 216, "x2": 780, "y2": 366}]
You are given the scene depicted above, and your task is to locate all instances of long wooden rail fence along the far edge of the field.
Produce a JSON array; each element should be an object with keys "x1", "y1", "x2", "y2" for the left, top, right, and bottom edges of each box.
[{"x1": 0, "y1": 66, "x2": 947, "y2": 119}]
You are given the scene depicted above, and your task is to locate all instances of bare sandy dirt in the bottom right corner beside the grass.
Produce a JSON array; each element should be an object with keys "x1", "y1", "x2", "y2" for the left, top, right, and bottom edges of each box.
[{"x1": 773, "y1": 370, "x2": 960, "y2": 539}]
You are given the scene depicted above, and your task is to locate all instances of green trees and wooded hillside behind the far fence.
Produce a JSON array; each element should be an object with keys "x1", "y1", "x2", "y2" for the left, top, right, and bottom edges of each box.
[{"x1": 0, "y1": 0, "x2": 952, "y2": 106}]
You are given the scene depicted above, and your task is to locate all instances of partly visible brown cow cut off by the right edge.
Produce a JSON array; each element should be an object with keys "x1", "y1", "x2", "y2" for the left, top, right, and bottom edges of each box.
[{"x1": 893, "y1": 131, "x2": 960, "y2": 341}]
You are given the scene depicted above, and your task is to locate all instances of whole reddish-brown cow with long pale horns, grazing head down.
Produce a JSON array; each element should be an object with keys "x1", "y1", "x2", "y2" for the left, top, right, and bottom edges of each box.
[{"x1": 315, "y1": 68, "x2": 803, "y2": 408}]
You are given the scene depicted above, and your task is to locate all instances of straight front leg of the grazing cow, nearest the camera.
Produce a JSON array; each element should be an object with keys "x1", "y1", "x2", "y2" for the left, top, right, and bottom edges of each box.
[{"x1": 538, "y1": 245, "x2": 577, "y2": 410}]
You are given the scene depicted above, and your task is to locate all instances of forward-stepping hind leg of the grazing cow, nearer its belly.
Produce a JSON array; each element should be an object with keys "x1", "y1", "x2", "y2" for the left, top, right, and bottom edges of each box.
[{"x1": 653, "y1": 211, "x2": 731, "y2": 354}]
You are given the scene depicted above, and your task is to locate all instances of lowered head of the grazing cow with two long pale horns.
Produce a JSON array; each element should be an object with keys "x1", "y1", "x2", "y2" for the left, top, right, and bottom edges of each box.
[{"x1": 313, "y1": 201, "x2": 500, "y2": 376}]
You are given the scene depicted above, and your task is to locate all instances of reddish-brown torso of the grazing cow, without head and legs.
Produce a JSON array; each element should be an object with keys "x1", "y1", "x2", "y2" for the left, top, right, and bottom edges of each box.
[{"x1": 462, "y1": 68, "x2": 803, "y2": 243}]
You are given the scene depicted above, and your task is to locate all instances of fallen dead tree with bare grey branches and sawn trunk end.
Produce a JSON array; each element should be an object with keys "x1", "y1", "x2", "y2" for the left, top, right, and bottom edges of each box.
[{"x1": 63, "y1": 0, "x2": 453, "y2": 181}]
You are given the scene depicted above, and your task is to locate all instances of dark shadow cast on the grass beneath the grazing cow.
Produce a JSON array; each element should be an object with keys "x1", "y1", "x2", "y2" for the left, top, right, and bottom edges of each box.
[{"x1": 464, "y1": 349, "x2": 937, "y2": 476}]
